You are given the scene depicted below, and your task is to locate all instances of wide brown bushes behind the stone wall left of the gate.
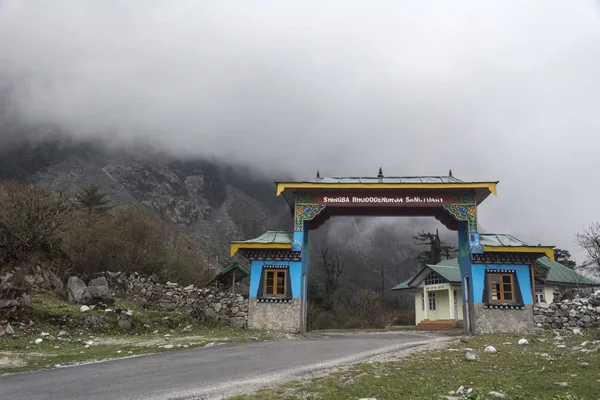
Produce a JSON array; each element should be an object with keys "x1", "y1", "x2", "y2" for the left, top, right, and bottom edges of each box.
[{"x1": 63, "y1": 205, "x2": 208, "y2": 284}]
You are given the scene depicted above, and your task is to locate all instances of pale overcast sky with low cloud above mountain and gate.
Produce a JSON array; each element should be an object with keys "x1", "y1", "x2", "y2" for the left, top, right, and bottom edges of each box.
[{"x1": 0, "y1": 0, "x2": 600, "y2": 258}]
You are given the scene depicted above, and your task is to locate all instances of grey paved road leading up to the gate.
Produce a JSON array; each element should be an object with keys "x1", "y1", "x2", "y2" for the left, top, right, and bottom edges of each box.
[{"x1": 0, "y1": 333, "x2": 434, "y2": 400}]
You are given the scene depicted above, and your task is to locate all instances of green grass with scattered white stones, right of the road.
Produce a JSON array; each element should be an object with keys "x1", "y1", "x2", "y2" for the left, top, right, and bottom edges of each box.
[{"x1": 231, "y1": 331, "x2": 600, "y2": 400}]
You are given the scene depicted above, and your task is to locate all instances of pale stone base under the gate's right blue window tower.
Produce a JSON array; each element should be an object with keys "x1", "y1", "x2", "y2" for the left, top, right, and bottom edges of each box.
[{"x1": 469, "y1": 303, "x2": 535, "y2": 334}]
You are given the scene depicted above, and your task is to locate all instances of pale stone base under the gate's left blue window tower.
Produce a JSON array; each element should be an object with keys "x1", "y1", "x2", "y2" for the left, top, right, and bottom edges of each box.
[{"x1": 248, "y1": 298, "x2": 302, "y2": 332}]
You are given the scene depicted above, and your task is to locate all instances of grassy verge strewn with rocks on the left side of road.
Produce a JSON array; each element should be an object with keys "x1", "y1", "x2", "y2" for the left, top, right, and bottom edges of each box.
[{"x1": 0, "y1": 295, "x2": 272, "y2": 374}]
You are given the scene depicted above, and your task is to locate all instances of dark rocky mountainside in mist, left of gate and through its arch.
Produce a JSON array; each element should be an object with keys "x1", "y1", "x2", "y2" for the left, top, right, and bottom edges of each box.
[{"x1": 0, "y1": 130, "x2": 435, "y2": 296}]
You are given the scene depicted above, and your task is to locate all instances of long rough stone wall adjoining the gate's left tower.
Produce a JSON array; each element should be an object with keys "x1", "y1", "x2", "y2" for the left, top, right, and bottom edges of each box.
[{"x1": 104, "y1": 272, "x2": 248, "y2": 328}]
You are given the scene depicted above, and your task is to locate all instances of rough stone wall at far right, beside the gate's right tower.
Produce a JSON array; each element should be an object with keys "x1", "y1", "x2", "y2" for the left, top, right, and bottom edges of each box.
[{"x1": 533, "y1": 290, "x2": 600, "y2": 330}]
